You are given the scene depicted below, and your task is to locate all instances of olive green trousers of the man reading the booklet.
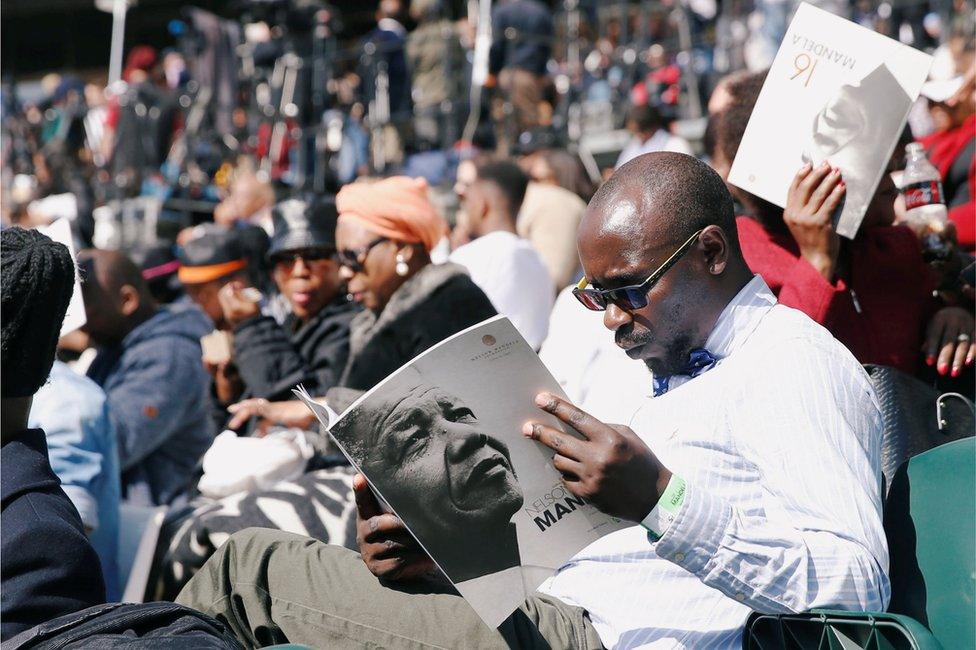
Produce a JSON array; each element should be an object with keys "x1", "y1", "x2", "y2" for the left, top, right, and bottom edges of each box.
[{"x1": 177, "y1": 528, "x2": 603, "y2": 650}]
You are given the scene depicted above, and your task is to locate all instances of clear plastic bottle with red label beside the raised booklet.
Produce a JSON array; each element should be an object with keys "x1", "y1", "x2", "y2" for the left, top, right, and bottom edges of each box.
[{"x1": 901, "y1": 142, "x2": 951, "y2": 262}]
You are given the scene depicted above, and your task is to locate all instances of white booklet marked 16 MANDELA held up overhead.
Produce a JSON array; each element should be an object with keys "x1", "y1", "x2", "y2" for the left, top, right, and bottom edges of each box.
[{"x1": 729, "y1": 3, "x2": 932, "y2": 238}]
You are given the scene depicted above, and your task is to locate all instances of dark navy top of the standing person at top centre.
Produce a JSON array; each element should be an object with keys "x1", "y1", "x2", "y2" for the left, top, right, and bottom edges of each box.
[{"x1": 488, "y1": 0, "x2": 555, "y2": 75}]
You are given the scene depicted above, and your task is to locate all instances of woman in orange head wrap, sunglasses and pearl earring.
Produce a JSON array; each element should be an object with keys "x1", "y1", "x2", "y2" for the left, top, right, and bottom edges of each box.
[{"x1": 328, "y1": 176, "x2": 496, "y2": 410}]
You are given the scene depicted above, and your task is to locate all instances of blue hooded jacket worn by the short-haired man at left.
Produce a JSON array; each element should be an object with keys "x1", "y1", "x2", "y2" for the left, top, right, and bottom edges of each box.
[{"x1": 88, "y1": 309, "x2": 213, "y2": 504}]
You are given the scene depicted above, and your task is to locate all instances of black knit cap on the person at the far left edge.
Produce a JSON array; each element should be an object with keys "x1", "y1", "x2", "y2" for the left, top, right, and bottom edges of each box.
[{"x1": 0, "y1": 227, "x2": 75, "y2": 397}]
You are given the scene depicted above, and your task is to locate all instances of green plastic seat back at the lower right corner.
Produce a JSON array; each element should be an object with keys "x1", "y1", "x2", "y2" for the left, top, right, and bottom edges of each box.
[{"x1": 884, "y1": 438, "x2": 976, "y2": 648}]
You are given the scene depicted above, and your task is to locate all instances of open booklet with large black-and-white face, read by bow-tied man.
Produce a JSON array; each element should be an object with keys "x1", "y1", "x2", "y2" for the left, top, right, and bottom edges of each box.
[{"x1": 296, "y1": 316, "x2": 633, "y2": 627}]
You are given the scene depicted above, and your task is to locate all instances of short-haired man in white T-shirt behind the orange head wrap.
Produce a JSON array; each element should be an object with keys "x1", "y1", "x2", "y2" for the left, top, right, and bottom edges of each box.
[{"x1": 450, "y1": 162, "x2": 553, "y2": 350}]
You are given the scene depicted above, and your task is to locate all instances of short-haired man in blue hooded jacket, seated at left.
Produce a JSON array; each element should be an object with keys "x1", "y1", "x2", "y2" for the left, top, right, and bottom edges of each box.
[{"x1": 79, "y1": 250, "x2": 213, "y2": 504}]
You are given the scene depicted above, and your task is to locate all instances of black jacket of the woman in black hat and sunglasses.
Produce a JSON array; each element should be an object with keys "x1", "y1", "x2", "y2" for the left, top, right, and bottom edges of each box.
[{"x1": 234, "y1": 297, "x2": 356, "y2": 400}]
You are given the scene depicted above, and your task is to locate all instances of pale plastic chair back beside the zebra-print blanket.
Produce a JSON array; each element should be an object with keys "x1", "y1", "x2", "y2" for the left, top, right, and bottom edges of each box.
[{"x1": 119, "y1": 503, "x2": 168, "y2": 603}]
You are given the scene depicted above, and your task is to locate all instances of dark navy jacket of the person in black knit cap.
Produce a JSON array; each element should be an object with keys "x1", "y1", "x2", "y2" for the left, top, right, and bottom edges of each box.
[{"x1": 0, "y1": 429, "x2": 105, "y2": 641}]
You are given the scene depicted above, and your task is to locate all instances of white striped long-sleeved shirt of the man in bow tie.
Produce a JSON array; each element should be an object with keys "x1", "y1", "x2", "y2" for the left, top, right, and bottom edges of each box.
[{"x1": 540, "y1": 276, "x2": 890, "y2": 650}]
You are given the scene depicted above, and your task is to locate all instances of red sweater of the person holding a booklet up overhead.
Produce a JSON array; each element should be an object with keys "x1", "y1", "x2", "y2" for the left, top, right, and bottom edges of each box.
[{"x1": 736, "y1": 217, "x2": 935, "y2": 374}]
